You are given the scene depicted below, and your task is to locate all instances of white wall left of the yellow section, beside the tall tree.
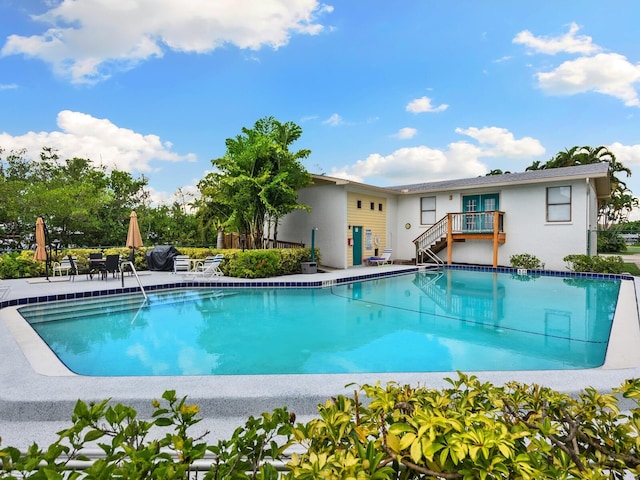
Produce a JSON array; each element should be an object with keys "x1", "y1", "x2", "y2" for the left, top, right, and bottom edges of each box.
[{"x1": 278, "y1": 185, "x2": 347, "y2": 268}]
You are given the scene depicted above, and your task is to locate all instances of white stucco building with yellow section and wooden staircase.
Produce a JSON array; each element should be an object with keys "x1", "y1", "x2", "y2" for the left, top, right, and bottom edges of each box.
[{"x1": 278, "y1": 163, "x2": 610, "y2": 270}]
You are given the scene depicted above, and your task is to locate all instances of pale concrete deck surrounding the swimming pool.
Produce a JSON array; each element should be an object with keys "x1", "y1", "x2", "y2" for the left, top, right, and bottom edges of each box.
[{"x1": 0, "y1": 265, "x2": 640, "y2": 448}]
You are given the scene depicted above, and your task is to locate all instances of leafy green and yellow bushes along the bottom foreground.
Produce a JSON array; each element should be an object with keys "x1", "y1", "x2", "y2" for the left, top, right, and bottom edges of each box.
[{"x1": 0, "y1": 374, "x2": 640, "y2": 480}]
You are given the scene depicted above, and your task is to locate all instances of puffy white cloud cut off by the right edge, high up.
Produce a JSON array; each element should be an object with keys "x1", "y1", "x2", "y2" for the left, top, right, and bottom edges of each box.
[{"x1": 536, "y1": 53, "x2": 640, "y2": 107}]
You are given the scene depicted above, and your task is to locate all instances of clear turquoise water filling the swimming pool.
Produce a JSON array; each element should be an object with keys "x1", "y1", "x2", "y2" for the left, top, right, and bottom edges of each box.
[{"x1": 20, "y1": 270, "x2": 620, "y2": 376}]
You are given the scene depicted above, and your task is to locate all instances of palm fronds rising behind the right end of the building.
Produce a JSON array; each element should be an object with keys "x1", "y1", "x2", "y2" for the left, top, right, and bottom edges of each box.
[{"x1": 527, "y1": 145, "x2": 639, "y2": 228}]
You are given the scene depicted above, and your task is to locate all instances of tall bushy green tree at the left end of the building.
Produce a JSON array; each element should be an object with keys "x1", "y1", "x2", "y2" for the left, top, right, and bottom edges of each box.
[{"x1": 208, "y1": 117, "x2": 311, "y2": 248}]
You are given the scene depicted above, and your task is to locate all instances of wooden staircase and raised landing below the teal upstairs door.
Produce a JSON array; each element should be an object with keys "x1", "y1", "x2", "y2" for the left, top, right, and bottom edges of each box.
[{"x1": 413, "y1": 210, "x2": 506, "y2": 267}]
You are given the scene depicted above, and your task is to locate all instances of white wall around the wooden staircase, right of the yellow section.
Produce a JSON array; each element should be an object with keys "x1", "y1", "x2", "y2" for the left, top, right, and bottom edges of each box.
[{"x1": 397, "y1": 179, "x2": 597, "y2": 270}]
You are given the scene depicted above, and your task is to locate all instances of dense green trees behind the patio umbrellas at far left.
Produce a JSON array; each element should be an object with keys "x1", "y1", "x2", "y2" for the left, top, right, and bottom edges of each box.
[{"x1": 0, "y1": 147, "x2": 147, "y2": 248}]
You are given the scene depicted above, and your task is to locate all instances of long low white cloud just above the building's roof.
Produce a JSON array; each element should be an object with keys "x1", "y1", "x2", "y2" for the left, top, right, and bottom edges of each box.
[{"x1": 329, "y1": 127, "x2": 544, "y2": 185}]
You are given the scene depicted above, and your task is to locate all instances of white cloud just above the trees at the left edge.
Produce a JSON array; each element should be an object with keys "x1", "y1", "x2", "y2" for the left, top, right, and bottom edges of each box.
[{"x1": 0, "y1": 110, "x2": 195, "y2": 172}]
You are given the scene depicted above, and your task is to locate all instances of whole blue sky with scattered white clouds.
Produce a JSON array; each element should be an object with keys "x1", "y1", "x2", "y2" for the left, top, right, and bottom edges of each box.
[{"x1": 0, "y1": 0, "x2": 640, "y2": 213}]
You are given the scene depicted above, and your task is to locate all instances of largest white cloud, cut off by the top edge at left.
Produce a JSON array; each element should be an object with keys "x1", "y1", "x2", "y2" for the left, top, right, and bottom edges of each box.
[{"x1": 0, "y1": 0, "x2": 333, "y2": 83}]
